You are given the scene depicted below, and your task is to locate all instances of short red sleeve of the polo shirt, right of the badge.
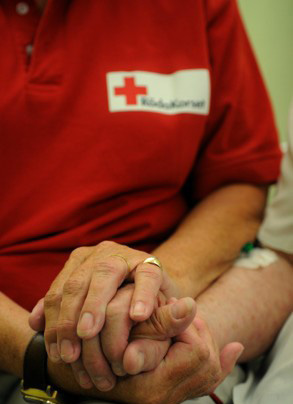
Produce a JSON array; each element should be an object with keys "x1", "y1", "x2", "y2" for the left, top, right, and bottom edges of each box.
[{"x1": 194, "y1": 0, "x2": 281, "y2": 199}]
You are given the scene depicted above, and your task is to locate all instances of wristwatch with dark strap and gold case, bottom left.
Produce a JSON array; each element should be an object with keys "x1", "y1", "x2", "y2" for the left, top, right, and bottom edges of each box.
[{"x1": 21, "y1": 332, "x2": 64, "y2": 404}]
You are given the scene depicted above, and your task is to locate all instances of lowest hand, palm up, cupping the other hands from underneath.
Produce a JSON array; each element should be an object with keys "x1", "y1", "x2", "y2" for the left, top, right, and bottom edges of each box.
[{"x1": 104, "y1": 306, "x2": 243, "y2": 404}]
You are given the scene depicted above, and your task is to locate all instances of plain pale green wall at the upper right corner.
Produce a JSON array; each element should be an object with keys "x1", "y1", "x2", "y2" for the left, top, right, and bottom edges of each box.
[{"x1": 238, "y1": 0, "x2": 293, "y2": 140}]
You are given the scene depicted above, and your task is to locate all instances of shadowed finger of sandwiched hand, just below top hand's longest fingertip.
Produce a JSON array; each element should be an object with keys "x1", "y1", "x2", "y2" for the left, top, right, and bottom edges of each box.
[{"x1": 82, "y1": 336, "x2": 116, "y2": 391}]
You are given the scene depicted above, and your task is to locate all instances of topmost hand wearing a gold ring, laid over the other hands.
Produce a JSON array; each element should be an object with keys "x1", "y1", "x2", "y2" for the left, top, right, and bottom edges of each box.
[{"x1": 30, "y1": 241, "x2": 178, "y2": 380}]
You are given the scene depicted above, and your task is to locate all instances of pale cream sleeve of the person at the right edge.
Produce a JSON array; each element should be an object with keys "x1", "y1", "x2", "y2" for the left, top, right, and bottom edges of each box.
[{"x1": 259, "y1": 104, "x2": 293, "y2": 254}]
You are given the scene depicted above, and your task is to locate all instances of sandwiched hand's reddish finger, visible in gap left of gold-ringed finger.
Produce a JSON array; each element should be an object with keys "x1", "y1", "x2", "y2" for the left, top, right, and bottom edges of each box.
[{"x1": 100, "y1": 285, "x2": 134, "y2": 376}]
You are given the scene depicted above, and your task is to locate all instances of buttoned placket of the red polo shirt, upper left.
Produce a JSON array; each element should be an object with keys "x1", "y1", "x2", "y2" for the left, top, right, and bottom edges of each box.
[{"x1": 4, "y1": 0, "x2": 65, "y2": 87}]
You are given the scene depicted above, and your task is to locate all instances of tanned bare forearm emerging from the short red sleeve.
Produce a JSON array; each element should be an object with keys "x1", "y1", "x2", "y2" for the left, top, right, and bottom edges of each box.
[{"x1": 153, "y1": 184, "x2": 266, "y2": 297}]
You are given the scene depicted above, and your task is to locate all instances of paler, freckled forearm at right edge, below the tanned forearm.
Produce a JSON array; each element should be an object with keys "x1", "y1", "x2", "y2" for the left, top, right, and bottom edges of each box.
[{"x1": 197, "y1": 259, "x2": 293, "y2": 361}]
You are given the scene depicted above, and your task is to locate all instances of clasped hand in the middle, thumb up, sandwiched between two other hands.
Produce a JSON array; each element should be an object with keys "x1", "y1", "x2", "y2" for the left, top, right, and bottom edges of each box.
[{"x1": 68, "y1": 285, "x2": 195, "y2": 391}]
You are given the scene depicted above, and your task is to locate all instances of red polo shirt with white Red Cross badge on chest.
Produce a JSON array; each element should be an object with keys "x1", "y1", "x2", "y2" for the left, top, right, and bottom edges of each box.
[{"x1": 0, "y1": 0, "x2": 280, "y2": 308}]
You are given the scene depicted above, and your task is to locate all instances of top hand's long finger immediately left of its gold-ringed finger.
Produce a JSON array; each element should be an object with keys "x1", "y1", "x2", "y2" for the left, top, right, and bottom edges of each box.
[{"x1": 76, "y1": 256, "x2": 128, "y2": 339}]
